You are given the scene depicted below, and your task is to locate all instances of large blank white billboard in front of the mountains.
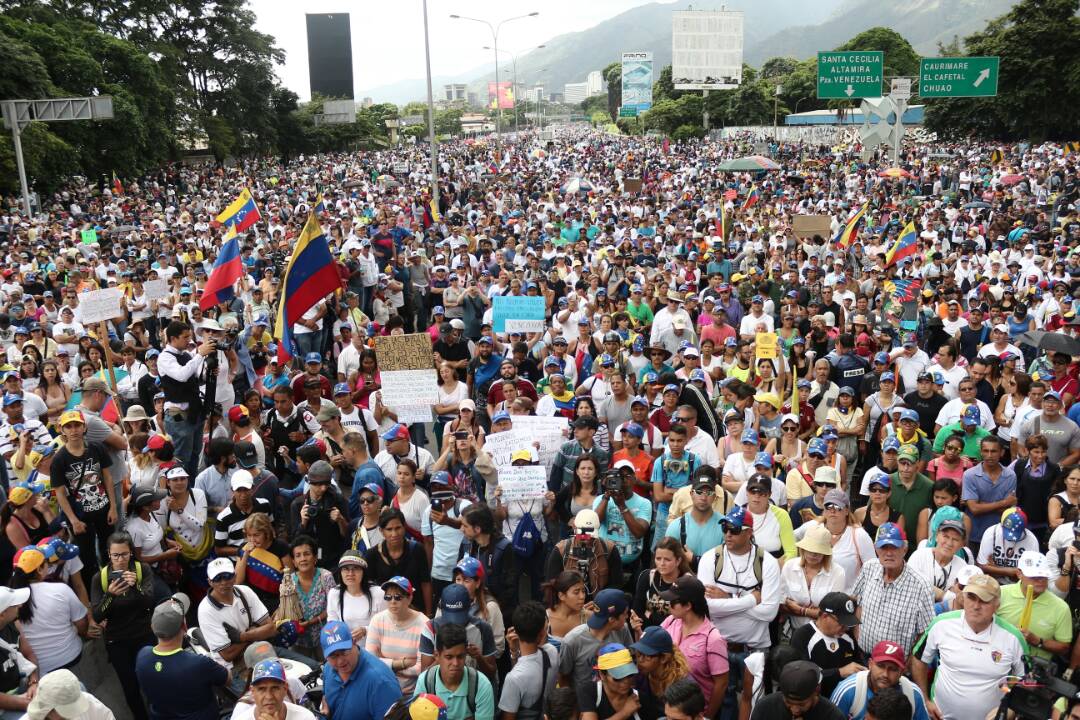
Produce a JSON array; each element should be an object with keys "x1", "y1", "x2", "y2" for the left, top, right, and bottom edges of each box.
[{"x1": 672, "y1": 10, "x2": 743, "y2": 90}]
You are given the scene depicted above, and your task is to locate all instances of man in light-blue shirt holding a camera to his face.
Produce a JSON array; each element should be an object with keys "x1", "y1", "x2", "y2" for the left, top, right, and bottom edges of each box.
[{"x1": 593, "y1": 460, "x2": 652, "y2": 580}]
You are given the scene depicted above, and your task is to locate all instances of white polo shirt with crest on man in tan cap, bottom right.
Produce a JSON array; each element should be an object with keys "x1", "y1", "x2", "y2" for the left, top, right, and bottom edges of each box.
[{"x1": 915, "y1": 610, "x2": 1027, "y2": 720}]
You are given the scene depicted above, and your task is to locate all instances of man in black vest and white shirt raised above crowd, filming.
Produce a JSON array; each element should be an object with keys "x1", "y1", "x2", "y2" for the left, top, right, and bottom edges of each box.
[{"x1": 158, "y1": 321, "x2": 220, "y2": 477}]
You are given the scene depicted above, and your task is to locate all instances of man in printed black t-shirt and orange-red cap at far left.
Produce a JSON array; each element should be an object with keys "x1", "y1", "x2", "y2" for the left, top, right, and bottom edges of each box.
[{"x1": 49, "y1": 410, "x2": 119, "y2": 587}]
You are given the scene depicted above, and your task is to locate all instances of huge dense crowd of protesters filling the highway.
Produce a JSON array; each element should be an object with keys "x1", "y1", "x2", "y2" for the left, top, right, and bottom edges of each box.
[{"x1": 0, "y1": 127, "x2": 1080, "y2": 720}]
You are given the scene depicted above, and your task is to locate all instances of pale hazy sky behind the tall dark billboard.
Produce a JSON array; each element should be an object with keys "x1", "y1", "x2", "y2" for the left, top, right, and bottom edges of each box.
[{"x1": 251, "y1": 0, "x2": 649, "y2": 100}]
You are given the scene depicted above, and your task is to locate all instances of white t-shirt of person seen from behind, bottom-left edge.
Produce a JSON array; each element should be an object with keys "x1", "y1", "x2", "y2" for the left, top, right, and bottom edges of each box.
[{"x1": 23, "y1": 583, "x2": 86, "y2": 675}]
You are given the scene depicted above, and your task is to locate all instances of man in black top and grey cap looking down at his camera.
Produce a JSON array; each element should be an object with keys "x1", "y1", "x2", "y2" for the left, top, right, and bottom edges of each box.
[{"x1": 289, "y1": 460, "x2": 349, "y2": 568}]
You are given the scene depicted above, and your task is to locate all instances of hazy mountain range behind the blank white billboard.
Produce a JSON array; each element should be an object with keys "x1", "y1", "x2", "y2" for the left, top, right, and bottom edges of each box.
[{"x1": 361, "y1": 0, "x2": 1016, "y2": 104}]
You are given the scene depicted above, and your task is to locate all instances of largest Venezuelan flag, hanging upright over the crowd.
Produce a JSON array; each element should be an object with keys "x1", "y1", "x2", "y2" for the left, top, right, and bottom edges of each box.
[{"x1": 274, "y1": 213, "x2": 341, "y2": 359}]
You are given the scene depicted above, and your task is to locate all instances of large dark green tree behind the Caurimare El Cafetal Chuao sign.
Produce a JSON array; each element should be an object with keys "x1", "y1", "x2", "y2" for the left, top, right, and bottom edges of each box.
[{"x1": 927, "y1": 0, "x2": 1080, "y2": 142}]
